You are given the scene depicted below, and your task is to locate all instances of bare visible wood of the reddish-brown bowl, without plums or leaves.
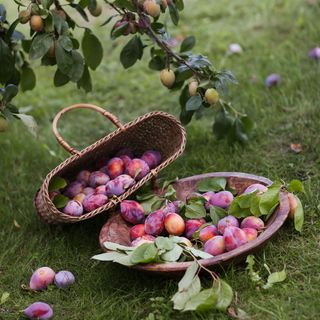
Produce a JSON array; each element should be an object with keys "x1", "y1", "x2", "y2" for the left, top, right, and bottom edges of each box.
[{"x1": 99, "y1": 172, "x2": 289, "y2": 276}]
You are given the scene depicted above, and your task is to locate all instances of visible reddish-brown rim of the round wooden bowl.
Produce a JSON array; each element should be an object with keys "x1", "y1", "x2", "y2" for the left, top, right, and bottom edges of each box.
[{"x1": 100, "y1": 172, "x2": 290, "y2": 275}]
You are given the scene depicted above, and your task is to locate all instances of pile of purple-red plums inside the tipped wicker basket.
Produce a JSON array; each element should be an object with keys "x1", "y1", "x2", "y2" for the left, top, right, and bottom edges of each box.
[{"x1": 50, "y1": 149, "x2": 161, "y2": 216}]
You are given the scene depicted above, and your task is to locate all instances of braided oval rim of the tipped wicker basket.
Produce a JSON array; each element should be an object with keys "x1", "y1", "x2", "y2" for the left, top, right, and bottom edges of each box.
[{"x1": 34, "y1": 111, "x2": 186, "y2": 223}]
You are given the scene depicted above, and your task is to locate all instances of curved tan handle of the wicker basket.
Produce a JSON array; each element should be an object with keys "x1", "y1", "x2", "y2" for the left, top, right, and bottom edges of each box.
[{"x1": 52, "y1": 103, "x2": 123, "y2": 154}]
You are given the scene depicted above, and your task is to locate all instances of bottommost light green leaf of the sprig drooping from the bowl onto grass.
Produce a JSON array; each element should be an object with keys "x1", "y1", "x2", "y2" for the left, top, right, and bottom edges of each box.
[{"x1": 183, "y1": 288, "x2": 218, "y2": 312}]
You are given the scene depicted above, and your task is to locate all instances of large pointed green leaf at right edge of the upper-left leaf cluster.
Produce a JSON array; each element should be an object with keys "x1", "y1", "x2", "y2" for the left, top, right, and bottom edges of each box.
[{"x1": 82, "y1": 29, "x2": 103, "y2": 70}]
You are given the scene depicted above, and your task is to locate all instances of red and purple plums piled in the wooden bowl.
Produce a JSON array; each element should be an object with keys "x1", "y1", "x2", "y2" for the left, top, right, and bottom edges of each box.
[{"x1": 120, "y1": 184, "x2": 268, "y2": 256}]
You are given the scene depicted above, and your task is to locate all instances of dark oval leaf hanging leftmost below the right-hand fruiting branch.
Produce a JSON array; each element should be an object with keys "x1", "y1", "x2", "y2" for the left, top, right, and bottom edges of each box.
[{"x1": 120, "y1": 36, "x2": 143, "y2": 69}]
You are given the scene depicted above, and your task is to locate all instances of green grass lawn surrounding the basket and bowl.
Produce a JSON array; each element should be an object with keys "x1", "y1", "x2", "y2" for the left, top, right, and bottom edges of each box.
[{"x1": 0, "y1": 0, "x2": 320, "y2": 320}]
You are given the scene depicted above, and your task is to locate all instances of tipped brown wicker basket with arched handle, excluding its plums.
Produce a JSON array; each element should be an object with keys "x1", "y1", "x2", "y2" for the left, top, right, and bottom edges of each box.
[{"x1": 34, "y1": 104, "x2": 186, "y2": 223}]
